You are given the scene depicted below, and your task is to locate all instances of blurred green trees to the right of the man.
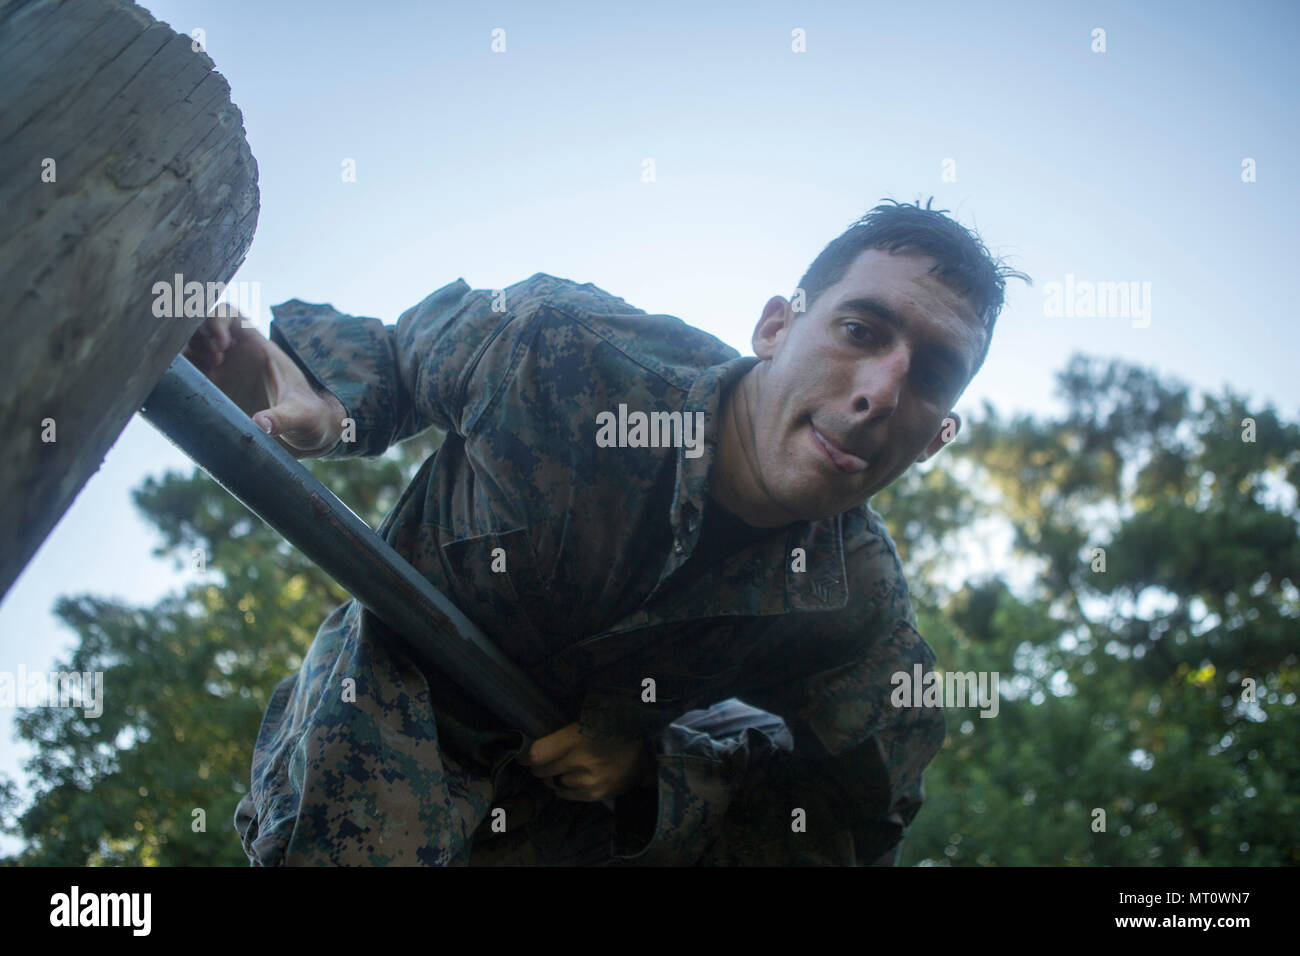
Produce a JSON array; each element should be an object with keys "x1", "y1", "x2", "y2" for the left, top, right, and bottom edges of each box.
[{"x1": 894, "y1": 358, "x2": 1300, "y2": 866}]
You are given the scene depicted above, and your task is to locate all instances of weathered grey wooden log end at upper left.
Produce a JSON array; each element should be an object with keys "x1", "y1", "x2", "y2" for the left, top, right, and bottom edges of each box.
[{"x1": 0, "y1": 0, "x2": 257, "y2": 596}]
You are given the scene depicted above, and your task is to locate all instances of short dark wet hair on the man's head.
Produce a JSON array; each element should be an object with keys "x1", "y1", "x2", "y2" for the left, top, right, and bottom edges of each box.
[{"x1": 800, "y1": 196, "x2": 1032, "y2": 377}]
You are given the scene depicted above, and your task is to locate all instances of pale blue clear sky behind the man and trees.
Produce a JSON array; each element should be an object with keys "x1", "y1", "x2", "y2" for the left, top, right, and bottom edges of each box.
[{"x1": 0, "y1": 0, "x2": 1300, "y2": 848}]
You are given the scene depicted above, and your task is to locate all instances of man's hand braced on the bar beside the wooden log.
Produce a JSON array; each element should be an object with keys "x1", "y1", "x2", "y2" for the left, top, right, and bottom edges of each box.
[{"x1": 182, "y1": 303, "x2": 347, "y2": 458}]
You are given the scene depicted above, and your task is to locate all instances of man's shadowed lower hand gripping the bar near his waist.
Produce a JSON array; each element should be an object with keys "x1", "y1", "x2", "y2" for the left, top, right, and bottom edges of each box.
[{"x1": 519, "y1": 723, "x2": 657, "y2": 803}]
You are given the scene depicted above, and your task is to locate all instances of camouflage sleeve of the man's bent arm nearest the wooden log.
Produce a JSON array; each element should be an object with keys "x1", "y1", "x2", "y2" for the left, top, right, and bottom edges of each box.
[{"x1": 270, "y1": 278, "x2": 493, "y2": 458}]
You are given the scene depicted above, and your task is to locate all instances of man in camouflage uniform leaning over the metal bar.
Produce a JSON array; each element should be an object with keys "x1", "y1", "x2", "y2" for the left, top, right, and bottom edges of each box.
[{"x1": 187, "y1": 197, "x2": 1014, "y2": 865}]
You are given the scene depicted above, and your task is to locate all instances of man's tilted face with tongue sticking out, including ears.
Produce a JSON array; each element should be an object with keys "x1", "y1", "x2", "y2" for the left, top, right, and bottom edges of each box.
[{"x1": 751, "y1": 248, "x2": 984, "y2": 520}]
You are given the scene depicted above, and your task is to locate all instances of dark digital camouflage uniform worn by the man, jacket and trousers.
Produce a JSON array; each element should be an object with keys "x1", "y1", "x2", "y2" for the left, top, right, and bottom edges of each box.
[{"x1": 235, "y1": 273, "x2": 945, "y2": 865}]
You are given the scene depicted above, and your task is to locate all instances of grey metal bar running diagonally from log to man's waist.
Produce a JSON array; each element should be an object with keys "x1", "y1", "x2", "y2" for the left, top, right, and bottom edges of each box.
[{"x1": 140, "y1": 355, "x2": 568, "y2": 737}]
